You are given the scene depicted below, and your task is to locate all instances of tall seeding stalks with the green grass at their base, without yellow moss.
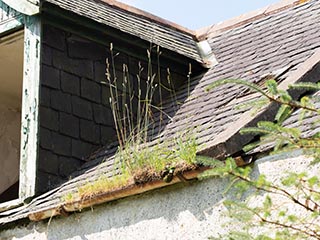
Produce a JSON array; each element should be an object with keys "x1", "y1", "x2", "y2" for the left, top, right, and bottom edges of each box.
[{"x1": 106, "y1": 45, "x2": 196, "y2": 181}]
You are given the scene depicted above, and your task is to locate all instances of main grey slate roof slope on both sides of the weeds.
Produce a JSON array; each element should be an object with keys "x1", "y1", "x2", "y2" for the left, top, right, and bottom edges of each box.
[{"x1": 0, "y1": 0, "x2": 320, "y2": 227}]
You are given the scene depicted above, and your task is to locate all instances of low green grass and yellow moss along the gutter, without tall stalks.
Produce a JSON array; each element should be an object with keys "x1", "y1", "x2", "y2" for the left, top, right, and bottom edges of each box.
[{"x1": 62, "y1": 135, "x2": 197, "y2": 203}]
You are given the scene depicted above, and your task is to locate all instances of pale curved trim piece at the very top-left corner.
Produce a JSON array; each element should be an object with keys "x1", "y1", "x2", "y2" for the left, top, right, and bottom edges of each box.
[{"x1": 2, "y1": 0, "x2": 40, "y2": 16}]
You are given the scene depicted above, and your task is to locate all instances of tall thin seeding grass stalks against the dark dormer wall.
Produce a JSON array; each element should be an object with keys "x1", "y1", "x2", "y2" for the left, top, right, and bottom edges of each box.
[{"x1": 106, "y1": 45, "x2": 162, "y2": 148}]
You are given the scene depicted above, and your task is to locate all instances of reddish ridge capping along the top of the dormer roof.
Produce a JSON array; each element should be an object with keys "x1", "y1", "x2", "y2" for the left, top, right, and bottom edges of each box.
[{"x1": 99, "y1": 0, "x2": 197, "y2": 40}]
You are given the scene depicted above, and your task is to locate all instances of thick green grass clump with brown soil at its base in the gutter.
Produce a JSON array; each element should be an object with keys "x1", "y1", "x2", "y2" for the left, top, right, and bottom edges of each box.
[{"x1": 116, "y1": 135, "x2": 197, "y2": 184}]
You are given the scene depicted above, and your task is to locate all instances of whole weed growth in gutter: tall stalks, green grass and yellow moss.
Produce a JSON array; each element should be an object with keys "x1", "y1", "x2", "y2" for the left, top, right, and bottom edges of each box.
[{"x1": 64, "y1": 44, "x2": 197, "y2": 202}]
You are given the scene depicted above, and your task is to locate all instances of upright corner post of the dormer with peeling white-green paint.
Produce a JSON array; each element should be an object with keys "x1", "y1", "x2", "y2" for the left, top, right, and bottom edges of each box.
[{"x1": 19, "y1": 14, "x2": 41, "y2": 200}]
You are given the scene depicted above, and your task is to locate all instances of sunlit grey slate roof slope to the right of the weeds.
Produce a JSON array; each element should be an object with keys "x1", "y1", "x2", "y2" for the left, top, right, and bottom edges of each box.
[{"x1": 159, "y1": 1, "x2": 320, "y2": 157}]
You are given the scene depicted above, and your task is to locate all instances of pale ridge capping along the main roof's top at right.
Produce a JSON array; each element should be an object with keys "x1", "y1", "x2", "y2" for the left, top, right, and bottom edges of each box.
[{"x1": 195, "y1": 0, "x2": 310, "y2": 41}]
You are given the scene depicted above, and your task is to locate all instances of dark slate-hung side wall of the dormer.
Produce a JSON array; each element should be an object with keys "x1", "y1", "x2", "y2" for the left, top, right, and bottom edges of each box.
[{"x1": 37, "y1": 25, "x2": 185, "y2": 192}]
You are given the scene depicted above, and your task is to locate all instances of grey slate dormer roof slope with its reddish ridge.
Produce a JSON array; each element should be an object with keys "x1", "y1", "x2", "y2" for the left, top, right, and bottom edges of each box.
[{"x1": 43, "y1": 0, "x2": 203, "y2": 63}]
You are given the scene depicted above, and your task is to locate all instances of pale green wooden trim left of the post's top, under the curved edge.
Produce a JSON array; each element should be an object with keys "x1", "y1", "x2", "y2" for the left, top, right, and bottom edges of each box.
[{"x1": 0, "y1": 0, "x2": 24, "y2": 36}]
